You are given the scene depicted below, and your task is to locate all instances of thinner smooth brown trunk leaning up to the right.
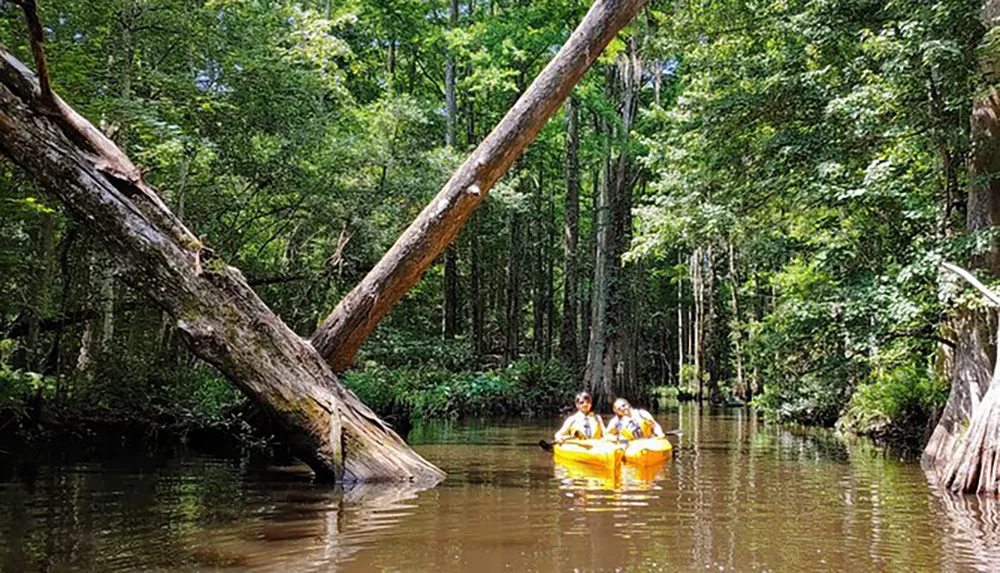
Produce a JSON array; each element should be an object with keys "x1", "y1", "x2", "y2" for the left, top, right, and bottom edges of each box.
[{"x1": 312, "y1": 0, "x2": 646, "y2": 372}]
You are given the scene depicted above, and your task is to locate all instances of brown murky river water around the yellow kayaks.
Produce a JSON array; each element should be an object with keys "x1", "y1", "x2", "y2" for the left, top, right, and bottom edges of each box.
[{"x1": 0, "y1": 406, "x2": 1000, "y2": 573}]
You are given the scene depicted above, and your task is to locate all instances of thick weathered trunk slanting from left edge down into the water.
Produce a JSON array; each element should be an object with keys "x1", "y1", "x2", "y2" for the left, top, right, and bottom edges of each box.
[{"x1": 0, "y1": 49, "x2": 444, "y2": 482}]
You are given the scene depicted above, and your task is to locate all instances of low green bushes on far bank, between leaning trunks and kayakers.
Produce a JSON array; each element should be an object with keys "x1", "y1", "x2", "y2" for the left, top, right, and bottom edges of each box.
[{"x1": 344, "y1": 360, "x2": 578, "y2": 420}]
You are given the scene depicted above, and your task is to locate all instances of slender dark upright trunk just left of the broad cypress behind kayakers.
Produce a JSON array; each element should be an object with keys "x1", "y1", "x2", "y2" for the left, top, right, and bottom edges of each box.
[{"x1": 559, "y1": 96, "x2": 580, "y2": 372}]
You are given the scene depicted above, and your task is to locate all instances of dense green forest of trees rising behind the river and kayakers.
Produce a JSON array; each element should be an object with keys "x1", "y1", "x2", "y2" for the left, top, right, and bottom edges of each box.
[{"x1": 0, "y1": 0, "x2": 997, "y2": 488}]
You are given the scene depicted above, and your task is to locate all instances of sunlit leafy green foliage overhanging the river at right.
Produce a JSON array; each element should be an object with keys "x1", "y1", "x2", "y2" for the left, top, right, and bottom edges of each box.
[{"x1": 628, "y1": 0, "x2": 990, "y2": 425}]
